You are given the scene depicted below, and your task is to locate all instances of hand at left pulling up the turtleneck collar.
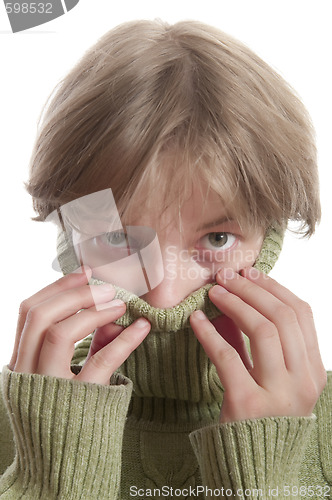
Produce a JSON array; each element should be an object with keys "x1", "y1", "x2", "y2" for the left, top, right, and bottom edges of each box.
[{"x1": 8, "y1": 268, "x2": 151, "y2": 384}]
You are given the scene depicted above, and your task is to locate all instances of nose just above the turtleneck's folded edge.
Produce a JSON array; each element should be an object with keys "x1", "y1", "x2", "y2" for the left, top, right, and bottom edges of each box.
[{"x1": 141, "y1": 247, "x2": 213, "y2": 309}]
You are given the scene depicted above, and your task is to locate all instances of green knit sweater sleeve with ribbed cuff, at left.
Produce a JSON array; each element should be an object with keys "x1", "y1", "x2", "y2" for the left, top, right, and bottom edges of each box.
[{"x1": 0, "y1": 367, "x2": 132, "y2": 500}]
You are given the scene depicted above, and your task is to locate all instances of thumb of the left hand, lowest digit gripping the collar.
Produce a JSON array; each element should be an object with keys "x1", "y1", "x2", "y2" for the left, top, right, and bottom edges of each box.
[{"x1": 77, "y1": 318, "x2": 151, "y2": 384}]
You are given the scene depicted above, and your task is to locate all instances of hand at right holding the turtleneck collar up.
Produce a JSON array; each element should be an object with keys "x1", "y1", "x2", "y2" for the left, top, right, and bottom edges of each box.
[{"x1": 190, "y1": 268, "x2": 326, "y2": 422}]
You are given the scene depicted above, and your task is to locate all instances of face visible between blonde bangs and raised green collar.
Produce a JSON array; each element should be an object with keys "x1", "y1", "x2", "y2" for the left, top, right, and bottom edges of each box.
[{"x1": 74, "y1": 185, "x2": 264, "y2": 308}]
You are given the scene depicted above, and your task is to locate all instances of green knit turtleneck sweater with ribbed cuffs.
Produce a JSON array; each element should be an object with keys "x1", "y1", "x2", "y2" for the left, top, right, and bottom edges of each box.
[{"x1": 0, "y1": 230, "x2": 332, "y2": 500}]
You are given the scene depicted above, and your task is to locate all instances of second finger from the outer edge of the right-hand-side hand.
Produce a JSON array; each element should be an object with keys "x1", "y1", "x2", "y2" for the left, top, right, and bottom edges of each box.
[{"x1": 217, "y1": 270, "x2": 307, "y2": 371}]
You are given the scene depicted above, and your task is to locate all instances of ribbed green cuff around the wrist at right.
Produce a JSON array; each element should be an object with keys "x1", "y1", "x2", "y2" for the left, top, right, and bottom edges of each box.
[{"x1": 190, "y1": 415, "x2": 316, "y2": 500}]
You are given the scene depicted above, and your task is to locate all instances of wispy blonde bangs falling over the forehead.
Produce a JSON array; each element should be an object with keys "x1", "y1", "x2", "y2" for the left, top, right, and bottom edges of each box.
[{"x1": 117, "y1": 148, "x2": 266, "y2": 231}]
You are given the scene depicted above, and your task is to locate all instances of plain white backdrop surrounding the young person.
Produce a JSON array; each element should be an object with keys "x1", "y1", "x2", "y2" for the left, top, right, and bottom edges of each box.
[{"x1": 0, "y1": 0, "x2": 332, "y2": 369}]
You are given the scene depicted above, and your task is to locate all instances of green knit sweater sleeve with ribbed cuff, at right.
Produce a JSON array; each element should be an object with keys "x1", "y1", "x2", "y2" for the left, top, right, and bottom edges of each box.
[{"x1": 190, "y1": 373, "x2": 332, "y2": 500}]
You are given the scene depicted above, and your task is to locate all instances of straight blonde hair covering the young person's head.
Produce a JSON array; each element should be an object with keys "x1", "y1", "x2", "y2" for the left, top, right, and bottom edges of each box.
[{"x1": 27, "y1": 21, "x2": 320, "y2": 236}]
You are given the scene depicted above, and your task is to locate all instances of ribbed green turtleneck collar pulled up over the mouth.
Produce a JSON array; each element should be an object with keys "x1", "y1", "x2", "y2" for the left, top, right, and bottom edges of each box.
[{"x1": 58, "y1": 228, "x2": 283, "y2": 425}]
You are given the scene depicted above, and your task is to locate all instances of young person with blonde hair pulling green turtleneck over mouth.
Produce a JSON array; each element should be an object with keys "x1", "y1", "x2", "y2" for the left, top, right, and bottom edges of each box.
[{"x1": 0, "y1": 21, "x2": 332, "y2": 499}]
